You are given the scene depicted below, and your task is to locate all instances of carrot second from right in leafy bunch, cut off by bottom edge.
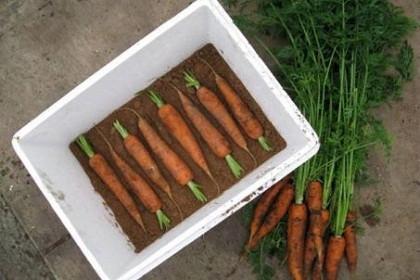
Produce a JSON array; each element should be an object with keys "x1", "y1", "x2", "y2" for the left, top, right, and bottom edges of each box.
[{"x1": 325, "y1": 236, "x2": 346, "y2": 280}]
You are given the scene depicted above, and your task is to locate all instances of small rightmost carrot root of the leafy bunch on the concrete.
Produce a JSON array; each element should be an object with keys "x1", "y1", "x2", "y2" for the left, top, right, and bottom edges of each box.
[{"x1": 343, "y1": 211, "x2": 357, "y2": 275}]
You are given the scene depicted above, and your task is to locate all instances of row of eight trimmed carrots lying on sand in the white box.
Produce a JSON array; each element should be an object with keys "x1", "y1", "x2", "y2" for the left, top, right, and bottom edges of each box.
[{"x1": 76, "y1": 58, "x2": 272, "y2": 233}]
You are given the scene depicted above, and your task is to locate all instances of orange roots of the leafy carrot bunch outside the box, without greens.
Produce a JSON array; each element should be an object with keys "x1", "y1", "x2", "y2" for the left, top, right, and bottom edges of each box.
[{"x1": 245, "y1": 176, "x2": 357, "y2": 280}]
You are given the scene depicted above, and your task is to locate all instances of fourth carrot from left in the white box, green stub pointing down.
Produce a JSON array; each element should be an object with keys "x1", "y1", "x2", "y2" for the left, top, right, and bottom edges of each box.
[{"x1": 118, "y1": 114, "x2": 207, "y2": 203}]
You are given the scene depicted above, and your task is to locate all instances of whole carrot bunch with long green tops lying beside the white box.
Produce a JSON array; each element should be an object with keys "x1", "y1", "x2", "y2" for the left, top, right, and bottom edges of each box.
[{"x1": 236, "y1": 0, "x2": 417, "y2": 280}]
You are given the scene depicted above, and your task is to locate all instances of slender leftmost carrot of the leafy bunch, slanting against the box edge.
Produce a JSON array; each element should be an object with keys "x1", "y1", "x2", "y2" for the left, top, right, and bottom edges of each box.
[{"x1": 248, "y1": 175, "x2": 290, "y2": 242}]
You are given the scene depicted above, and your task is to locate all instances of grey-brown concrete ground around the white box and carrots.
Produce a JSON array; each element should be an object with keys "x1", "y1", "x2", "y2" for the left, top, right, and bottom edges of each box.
[{"x1": 0, "y1": 0, "x2": 420, "y2": 280}]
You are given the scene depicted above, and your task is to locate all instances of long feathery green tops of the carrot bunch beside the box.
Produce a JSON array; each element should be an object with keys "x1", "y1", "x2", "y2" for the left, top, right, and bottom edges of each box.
[{"x1": 230, "y1": 0, "x2": 417, "y2": 279}]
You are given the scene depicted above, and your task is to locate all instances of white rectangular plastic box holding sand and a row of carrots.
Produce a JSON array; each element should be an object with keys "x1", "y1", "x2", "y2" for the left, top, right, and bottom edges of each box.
[{"x1": 12, "y1": 0, "x2": 319, "y2": 280}]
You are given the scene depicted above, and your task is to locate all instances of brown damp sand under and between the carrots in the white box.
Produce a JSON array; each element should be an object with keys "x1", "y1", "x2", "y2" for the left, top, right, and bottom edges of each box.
[{"x1": 70, "y1": 45, "x2": 286, "y2": 252}]
